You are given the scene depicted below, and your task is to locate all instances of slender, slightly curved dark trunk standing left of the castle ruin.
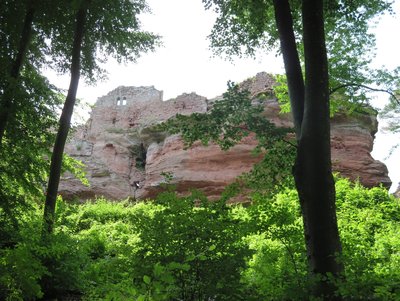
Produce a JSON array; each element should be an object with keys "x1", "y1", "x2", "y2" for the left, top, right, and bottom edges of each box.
[{"x1": 44, "y1": 8, "x2": 86, "y2": 233}]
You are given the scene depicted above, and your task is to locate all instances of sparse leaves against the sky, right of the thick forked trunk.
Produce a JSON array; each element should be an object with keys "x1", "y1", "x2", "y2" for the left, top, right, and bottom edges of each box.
[{"x1": 325, "y1": 0, "x2": 398, "y2": 112}]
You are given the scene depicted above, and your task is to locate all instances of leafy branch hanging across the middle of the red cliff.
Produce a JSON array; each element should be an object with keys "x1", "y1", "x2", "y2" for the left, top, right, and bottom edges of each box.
[{"x1": 159, "y1": 82, "x2": 291, "y2": 150}]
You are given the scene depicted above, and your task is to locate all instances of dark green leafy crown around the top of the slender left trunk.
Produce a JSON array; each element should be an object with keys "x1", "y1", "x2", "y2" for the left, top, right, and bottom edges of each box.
[{"x1": 36, "y1": 0, "x2": 159, "y2": 82}]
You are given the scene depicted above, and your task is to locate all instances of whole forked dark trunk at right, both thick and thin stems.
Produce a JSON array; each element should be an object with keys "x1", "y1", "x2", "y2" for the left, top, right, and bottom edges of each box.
[{"x1": 274, "y1": 0, "x2": 343, "y2": 300}]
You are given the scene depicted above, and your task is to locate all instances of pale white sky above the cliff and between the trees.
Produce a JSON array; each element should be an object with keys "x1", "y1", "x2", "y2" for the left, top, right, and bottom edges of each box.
[{"x1": 46, "y1": 0, "x2": 400, "y2": 188}]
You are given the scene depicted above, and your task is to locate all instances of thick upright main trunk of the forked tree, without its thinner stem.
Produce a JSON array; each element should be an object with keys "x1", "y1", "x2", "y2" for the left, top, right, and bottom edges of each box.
[{"x1": 294, "y1": 0, "x2": 343, "y2": 300}]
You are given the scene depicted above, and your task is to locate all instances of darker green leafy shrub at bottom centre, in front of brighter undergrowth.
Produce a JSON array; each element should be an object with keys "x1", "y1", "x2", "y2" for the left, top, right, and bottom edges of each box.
[{"x1": 134, "y1": 192, "x2": 250, "y2": 300}]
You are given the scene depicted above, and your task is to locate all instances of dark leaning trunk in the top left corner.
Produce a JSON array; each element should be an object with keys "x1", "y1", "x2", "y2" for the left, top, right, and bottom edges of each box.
[{"x1": 0, "y1": 0, "x2": 36, "y2": 144}]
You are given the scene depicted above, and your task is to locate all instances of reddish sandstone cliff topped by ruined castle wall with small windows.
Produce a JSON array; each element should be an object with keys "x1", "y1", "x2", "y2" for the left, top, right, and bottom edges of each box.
[{"x1": 59, "y1": 73, "x2": 391, "y2": 199}]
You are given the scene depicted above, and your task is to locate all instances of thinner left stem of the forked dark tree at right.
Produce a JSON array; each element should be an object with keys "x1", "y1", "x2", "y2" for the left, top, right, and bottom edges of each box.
[{"x1": 274, "y1": 0, "x2": 304, "y2": 140}]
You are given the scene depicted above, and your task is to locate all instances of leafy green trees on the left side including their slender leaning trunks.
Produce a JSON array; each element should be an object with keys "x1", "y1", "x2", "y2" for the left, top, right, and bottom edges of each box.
[{"x1": 0, "y1": 0, "x2": 159, "y2": 230}]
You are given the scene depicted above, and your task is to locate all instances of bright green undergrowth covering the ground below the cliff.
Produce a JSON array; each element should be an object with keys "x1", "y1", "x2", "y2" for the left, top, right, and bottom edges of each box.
[{"x1": 0, "y1": 179, "x2": 400, "y2": 300}]
